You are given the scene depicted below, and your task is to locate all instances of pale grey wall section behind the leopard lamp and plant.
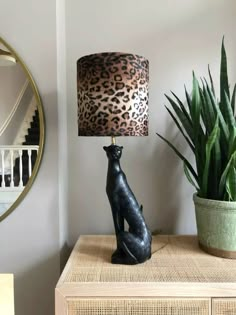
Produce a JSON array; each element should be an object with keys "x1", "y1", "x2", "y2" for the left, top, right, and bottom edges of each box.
[{"x1": 65, "y1": 0, "x2": 236, "y2": 244}]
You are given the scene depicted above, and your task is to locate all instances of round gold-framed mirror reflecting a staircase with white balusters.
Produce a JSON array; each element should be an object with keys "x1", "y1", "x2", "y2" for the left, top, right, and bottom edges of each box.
[{"x1": 0, "y1": 37, "x2": 45, "y2": 221}]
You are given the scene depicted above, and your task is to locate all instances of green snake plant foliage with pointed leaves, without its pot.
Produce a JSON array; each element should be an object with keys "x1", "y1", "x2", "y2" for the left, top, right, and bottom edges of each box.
[{"x1": 157, "y1": 39, "x2": 236, "y2": 201}]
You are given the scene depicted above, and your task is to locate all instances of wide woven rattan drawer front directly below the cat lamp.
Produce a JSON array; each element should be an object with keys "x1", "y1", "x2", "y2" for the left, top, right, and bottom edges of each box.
[{"x1": 67, "y1": 298, "x2": 211, "y2": 315}]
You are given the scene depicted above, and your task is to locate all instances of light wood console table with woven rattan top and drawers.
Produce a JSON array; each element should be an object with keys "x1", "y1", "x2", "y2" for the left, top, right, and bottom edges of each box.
[{"x1": 55, "y1": 236, "x2": 236, "y2": 315}]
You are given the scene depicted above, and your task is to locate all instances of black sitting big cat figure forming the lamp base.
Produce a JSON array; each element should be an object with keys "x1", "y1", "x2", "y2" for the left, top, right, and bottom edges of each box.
[{"x1": 103, "y1": 144, "x2": 152, "y2": 265}]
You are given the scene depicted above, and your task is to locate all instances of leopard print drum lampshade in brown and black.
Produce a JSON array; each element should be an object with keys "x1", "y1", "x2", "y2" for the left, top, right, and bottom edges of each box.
[{"x1": 77, "y1": 52, "x2": 149, "y2": 136}]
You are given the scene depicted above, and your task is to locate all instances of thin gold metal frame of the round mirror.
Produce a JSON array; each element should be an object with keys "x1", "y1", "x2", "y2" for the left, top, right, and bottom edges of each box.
[{"x1": 0, "y1": 37, "x2": 45, "y2": 222}]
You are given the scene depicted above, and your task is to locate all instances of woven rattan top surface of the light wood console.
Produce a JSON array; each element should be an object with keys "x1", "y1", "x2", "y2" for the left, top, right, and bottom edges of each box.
[{"x1": 59, "y1": 235, "x2": 236, "y2": 285}]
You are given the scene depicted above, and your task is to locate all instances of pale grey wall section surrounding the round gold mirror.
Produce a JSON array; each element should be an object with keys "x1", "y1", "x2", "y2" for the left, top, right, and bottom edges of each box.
[{"x1": 0, "y1": 0, "x2": 59, "y2": 315}]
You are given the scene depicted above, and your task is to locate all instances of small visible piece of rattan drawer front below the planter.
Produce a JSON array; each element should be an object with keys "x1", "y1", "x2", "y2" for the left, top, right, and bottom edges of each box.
[{"x1": 212, "y1": 298, "x2": 236, "y2": 315}]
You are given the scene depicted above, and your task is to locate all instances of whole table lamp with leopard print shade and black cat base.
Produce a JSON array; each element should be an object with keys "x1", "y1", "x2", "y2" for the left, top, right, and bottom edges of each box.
[{"x1": 77, "y1": 52, "x2": 152, "y2": 265}]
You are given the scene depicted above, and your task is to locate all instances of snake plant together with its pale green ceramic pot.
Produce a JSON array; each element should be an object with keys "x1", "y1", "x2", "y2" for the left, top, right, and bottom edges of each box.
[{"x1": 157, "y1": 39, "x2": 236, "y2": 258}]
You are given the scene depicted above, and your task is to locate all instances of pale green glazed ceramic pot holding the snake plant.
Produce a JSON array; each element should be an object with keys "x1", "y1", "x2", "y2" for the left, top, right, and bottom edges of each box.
[{"x1": 193, "y1": 194, "x2": 236, "y2": 259}]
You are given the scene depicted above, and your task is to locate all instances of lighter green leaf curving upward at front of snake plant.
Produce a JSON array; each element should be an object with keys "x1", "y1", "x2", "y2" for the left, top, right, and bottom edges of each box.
[{"x1": 201, "y1": 116, "x2": 220, "y2": 198}]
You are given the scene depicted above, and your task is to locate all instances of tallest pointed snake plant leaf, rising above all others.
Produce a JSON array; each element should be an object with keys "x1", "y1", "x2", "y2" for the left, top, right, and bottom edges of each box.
[{"x1": 220, "y1": 38, "x2": 230, "y2": 119}]
